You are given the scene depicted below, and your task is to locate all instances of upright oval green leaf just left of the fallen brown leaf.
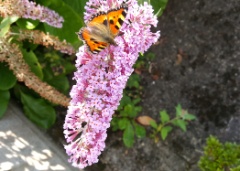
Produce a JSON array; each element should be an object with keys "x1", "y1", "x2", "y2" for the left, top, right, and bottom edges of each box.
[{"x1": 123, "y1": 122, "x2": 134, "y2": 147}]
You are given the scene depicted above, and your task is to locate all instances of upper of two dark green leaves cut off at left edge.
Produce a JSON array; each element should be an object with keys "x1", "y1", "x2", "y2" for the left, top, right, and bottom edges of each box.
[{"x1": 0, "y1": 62, "x2": 17, "y2": 90}]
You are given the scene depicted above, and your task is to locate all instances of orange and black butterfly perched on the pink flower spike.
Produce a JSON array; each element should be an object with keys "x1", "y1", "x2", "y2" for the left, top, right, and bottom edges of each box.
[{"x1": 77, "y1": 3, "x2": 128, "y2": 54}]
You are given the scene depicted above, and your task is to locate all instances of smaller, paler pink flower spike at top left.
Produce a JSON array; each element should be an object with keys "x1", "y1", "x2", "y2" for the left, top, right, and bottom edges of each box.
[{"x1": 16, "y1": 0, "x2": 64, "y2": 28}]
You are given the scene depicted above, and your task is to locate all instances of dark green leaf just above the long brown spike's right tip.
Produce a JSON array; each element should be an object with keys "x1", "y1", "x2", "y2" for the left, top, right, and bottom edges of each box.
[{"x1": 47, "y1": 75, "x2": 70, "y2": 93}]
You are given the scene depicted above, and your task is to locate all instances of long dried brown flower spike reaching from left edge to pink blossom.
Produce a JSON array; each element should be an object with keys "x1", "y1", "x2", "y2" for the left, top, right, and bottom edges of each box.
[{"x1": 0, "y1": 38, "x2": 70, "y2": 107}]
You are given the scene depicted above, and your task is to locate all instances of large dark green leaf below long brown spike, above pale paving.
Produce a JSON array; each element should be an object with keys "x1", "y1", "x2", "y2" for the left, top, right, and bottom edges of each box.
[{"x1": 21, "y1": 92, "x2": 56, "y2": 129}]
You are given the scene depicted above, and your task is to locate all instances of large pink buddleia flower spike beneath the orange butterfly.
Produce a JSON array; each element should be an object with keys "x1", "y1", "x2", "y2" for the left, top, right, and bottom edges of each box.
[{"x1": 64, "y1": 0, "x2": 160, "y2": 168}]
